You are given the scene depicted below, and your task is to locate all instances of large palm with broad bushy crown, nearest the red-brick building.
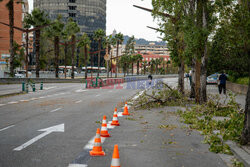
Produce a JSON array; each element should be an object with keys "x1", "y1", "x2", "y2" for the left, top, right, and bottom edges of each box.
[{"x1": 24, "y1": 8, "x2": 49, "y2": 78}]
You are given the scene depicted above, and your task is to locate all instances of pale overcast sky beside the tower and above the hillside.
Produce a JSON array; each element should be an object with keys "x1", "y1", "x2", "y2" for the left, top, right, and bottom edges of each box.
[{"x1": 29, "y1": 0, "x2": 160, "y2": 41}]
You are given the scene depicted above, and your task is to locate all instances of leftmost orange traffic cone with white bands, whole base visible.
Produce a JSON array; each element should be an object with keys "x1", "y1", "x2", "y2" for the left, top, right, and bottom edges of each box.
[{"x1": 89, "y1": 128, "x2": 105, "y2": 156}]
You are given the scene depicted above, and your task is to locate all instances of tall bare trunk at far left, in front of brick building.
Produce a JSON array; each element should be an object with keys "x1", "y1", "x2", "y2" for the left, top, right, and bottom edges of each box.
[{"x1": 8, "y1": 0, "x2": 15, "y2": 77}]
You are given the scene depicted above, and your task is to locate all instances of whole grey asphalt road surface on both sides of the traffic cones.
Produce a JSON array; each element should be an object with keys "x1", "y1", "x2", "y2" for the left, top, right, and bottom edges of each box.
[{"x1": 0, "y1": 78, "x2": 229, "y2": 167}]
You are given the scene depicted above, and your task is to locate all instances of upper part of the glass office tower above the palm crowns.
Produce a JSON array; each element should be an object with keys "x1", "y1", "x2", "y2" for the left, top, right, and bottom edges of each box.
[{"x1": 34, "y1": 0, "x2": 106, "y2": 34}]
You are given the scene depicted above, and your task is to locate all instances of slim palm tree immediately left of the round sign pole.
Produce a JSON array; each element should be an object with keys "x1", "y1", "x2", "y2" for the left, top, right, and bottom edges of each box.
[{"x1": 94, "y1": 29, "x2": 105, "y2": 77}]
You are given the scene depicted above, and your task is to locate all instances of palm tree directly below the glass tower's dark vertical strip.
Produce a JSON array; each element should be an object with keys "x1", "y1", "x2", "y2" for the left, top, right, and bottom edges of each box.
[{"x1": 65, "y1": 18, "x2": 80, "y2": 79}]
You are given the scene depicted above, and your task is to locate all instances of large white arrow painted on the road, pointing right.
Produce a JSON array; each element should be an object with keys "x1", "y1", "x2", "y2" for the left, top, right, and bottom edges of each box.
[{"x1": 13, "y1": 124, "x2": 64, "y2": 151}]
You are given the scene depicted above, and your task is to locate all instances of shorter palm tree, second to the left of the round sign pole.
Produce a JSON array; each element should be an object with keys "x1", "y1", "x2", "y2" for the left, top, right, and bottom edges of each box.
[{"x1": 78, "y1": 33, "x2": 91, "y2": 79}]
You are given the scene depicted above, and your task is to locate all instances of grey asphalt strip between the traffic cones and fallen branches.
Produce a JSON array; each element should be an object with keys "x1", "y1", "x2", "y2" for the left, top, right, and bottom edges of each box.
[{"x1": 88, "y1": 107, "x2": 229, "y2": 167}]
